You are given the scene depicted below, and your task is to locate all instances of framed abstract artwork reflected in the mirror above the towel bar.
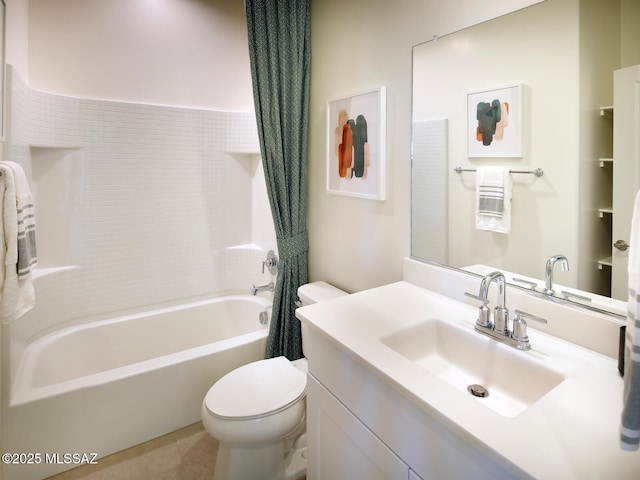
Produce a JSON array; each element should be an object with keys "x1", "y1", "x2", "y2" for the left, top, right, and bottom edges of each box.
[{"x1": 467, "y1": 85, "x2": 523, "y2": 158}]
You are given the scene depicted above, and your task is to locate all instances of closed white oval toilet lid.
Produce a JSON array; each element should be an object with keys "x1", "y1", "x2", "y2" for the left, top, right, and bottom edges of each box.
[{"x1": 205, "y1": 357, "x2": 307, "y2": 418}]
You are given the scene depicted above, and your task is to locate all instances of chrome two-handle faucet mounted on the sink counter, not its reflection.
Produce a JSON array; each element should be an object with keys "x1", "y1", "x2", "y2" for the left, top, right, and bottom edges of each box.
[{"x1": 465, "y1": 272, "x2": 547, "y2": 350}]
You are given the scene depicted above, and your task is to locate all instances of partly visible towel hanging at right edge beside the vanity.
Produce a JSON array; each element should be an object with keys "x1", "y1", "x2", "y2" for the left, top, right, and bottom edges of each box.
[{"x1": 620, "y1": 192, "x2": 640, "y2": 451}]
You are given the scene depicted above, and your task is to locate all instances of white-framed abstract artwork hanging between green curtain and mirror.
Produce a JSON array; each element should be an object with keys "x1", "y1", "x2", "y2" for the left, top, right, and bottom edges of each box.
[{"x1": 327, "y1": 87, "x2": 386, "y2": 200}]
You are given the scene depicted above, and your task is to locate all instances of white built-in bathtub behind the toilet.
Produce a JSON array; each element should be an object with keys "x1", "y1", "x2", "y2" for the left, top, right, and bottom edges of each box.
[{"x1": 3, "y1": 295, "x2": 271, "y2": 480}]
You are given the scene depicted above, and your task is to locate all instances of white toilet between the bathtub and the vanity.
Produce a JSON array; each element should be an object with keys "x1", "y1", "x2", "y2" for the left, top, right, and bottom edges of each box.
[{"x1": 200, "y1": 282, "x2": 346, "y2": 480}]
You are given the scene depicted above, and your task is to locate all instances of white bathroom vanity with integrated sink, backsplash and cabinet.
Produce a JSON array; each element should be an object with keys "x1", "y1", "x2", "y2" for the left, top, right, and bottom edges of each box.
[{"x1": 297, "y1": 259, "x2": 640, "y2": 480}]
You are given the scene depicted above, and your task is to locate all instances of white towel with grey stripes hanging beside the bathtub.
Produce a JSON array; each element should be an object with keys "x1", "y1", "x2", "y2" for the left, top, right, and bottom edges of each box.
[{"x1": 0, "y1": 161, "x2": 37, "y2": 323}]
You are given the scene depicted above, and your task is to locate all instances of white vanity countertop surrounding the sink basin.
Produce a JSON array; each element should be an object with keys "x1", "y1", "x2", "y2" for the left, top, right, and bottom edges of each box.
[{"x1": 297, "y1": 281, "x2": 640, "y2": 480}]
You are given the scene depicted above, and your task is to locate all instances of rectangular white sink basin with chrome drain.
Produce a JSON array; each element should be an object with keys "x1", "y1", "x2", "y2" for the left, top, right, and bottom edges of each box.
[{"x1": 380, "y1": 318, "x2": 564, "y2": 417}]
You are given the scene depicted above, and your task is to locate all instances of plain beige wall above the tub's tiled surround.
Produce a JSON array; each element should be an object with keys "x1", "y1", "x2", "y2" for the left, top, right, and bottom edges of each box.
[{"x1": 29, "y1": 0, "x2": 253, "y2": 111}]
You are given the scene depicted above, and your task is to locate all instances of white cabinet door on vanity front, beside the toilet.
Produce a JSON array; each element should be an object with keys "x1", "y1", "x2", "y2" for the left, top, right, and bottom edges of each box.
[{"x1": 307, "y1": 375, "x2": 409, "y2": 480}]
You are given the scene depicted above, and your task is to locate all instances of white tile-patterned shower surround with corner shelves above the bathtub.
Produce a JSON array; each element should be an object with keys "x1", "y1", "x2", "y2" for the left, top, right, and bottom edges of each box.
[{"x1": 5, "y1": 67, "x2": 275, "y2": 382}]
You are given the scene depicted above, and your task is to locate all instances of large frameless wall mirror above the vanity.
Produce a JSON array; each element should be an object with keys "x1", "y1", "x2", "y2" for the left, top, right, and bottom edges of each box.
[{"x1": 411, "y1": 0, "x2": 640, "y2": 315}]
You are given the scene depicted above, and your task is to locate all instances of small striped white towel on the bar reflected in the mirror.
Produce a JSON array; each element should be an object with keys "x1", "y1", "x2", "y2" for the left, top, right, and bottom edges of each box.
[{"x1": 476, "y1": 167, "x2": 512, "y2": 234}]
